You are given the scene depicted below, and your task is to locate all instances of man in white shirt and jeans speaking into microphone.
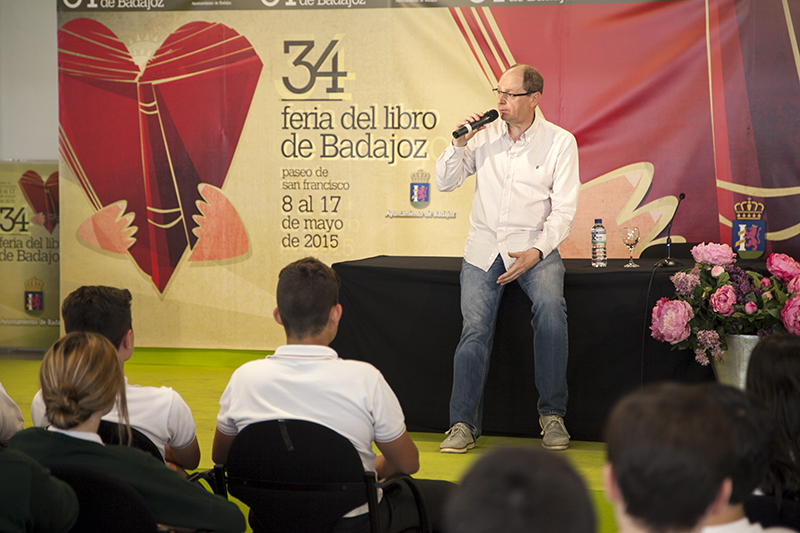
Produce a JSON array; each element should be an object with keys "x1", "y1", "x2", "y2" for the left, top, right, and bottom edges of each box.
[{"x1": 436, "y1": 65, "x2": 580, "y2": 453}]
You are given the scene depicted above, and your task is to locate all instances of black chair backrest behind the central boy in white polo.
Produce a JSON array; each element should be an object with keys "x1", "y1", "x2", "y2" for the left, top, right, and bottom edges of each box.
[{"x1": 226, "y1": 420, "x2": 379, "y2": 533}]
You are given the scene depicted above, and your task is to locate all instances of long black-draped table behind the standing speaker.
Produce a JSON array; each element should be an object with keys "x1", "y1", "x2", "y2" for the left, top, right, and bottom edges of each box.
[{"x1": 331, "y1": 256, "x2": 764, "y2": 440}]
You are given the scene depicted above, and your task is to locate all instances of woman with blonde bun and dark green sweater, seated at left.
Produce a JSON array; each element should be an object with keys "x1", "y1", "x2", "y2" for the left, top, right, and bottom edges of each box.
[{"x1": 9, "y1": 332, "x2": 246, "y2": 533}]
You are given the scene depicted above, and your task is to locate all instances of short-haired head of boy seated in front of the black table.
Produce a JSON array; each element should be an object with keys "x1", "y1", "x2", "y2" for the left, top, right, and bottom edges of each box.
[{"x1": 275, "y1": 257, "x2": 341, "y2": 340}]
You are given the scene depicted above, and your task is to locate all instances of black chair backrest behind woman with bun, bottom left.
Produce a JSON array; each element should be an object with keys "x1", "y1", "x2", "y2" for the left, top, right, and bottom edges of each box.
[{"x1": 48, "y1": 465, "x2": 157, "y2": 533}]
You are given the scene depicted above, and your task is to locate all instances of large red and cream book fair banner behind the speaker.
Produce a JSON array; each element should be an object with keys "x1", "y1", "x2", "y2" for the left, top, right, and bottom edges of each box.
[{"x1": 58, "y1": 0, "x2": 800, "y2": 348}]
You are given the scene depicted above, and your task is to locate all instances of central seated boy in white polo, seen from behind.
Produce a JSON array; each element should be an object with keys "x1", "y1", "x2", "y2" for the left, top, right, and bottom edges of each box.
[{"x1": 212, "y1": 257, "x2": 452, "y2": 532}]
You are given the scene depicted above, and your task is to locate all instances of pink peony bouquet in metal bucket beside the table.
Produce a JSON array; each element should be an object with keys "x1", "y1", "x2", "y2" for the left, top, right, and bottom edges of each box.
[{"x1": 650, "y1": 243, "x2": 800, "y2": 365}]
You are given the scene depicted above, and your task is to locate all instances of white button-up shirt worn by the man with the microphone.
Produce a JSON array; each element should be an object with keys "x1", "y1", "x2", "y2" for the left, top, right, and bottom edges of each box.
[{"x1": 436, "y1": 107, "x2": 580, "y2": 271}]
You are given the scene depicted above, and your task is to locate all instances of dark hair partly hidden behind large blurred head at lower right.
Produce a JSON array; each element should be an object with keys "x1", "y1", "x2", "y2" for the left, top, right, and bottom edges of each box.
[{"x1": 701, "y1": 383, "x2": 772, "y2": 508}]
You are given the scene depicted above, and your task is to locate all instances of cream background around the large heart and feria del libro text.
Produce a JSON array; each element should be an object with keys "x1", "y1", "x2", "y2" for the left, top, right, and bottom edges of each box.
[{"x1": 59, "y1": 9, "x2": 495, "y2": 349}]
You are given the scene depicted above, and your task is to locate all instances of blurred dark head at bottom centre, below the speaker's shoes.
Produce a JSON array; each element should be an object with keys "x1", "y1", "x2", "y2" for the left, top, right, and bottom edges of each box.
[{"x1": 445, "y1": 448, "x2": 595, "y2": 533}]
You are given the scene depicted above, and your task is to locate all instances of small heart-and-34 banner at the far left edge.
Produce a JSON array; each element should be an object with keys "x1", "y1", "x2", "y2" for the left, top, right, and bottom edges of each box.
[{"x1": 0, "y1": 161, "x2": 61, "y2": 350}]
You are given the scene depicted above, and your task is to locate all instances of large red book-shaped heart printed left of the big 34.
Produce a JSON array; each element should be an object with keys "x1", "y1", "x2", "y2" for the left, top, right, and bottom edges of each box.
[{"x1": 58, "y1": 19, "x2": 262, "y2": 293}]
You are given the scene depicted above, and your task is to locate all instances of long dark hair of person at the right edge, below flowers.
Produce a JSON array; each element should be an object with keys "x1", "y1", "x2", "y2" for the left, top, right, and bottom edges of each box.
[{"x1": 746, "y1": 333, "x2": 800, "y2": 499}]
